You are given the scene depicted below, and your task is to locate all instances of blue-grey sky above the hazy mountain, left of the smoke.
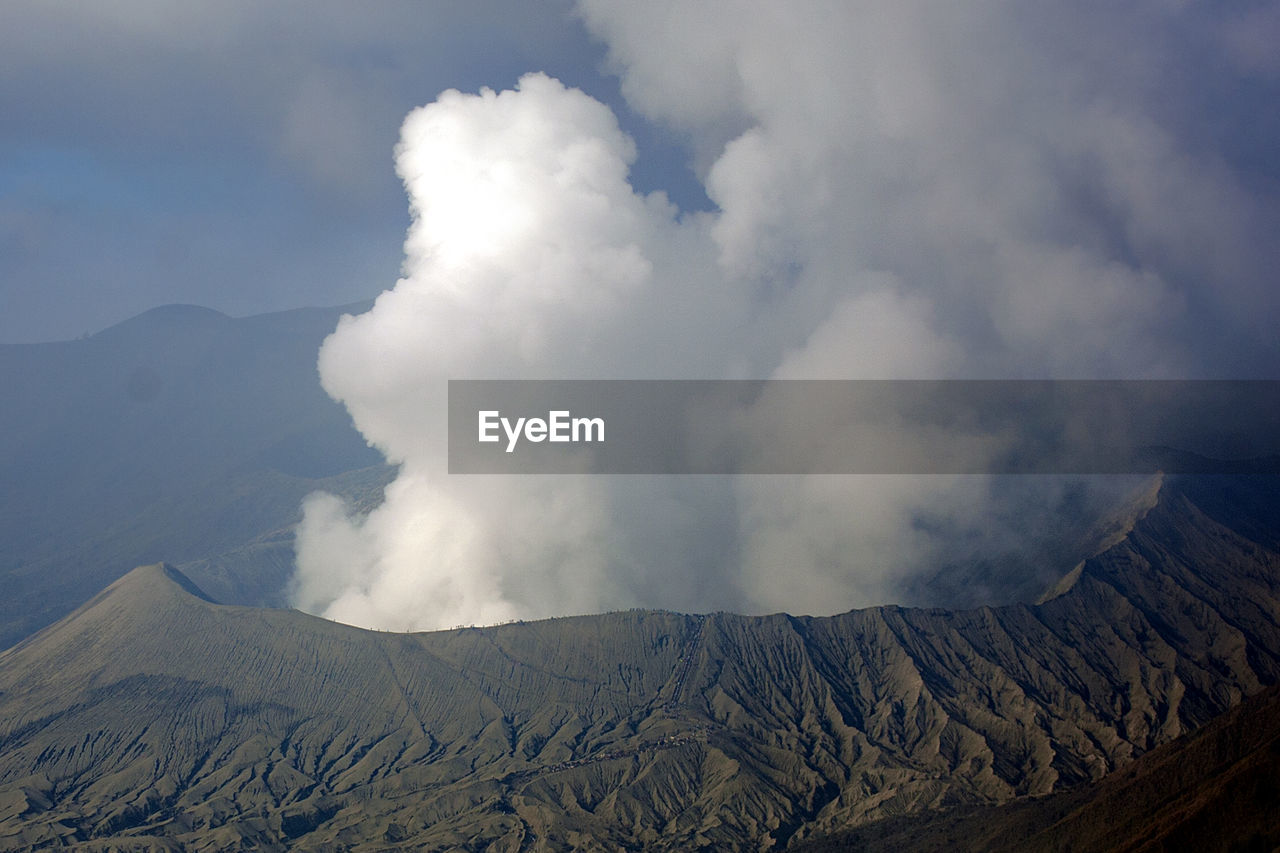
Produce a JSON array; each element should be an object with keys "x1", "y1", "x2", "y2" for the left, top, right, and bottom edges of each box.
[{"x1": 0, "y1": 0, "x2": 709, "y2": 343}]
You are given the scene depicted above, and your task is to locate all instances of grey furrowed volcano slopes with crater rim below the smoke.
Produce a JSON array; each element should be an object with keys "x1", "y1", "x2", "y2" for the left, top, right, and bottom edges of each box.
[{"x1": 0, "y1": 478, "x2": 1280, "y2": 850}]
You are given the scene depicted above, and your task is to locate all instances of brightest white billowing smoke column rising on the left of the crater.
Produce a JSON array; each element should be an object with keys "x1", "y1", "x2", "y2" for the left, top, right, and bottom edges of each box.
[{"x1": 286, "y1": 74, "x2": 669, "y2": 630}]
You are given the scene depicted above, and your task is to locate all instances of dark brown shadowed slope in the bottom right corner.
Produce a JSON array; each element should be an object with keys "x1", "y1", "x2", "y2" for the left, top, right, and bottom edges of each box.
[{"x1": 796, "y1": 686, "x2": 1280, "y2": 853}]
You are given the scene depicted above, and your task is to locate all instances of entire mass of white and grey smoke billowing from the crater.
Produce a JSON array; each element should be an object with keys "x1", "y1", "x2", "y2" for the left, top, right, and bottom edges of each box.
[{"x1": 294, "y1": 0, "x2": 1280, "y2": 629}]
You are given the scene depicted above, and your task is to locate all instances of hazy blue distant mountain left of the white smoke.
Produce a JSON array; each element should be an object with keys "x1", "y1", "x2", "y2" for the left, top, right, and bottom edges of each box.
[{"x1": 0, "y1": 298, "x2": 388, "y2": 646}]
